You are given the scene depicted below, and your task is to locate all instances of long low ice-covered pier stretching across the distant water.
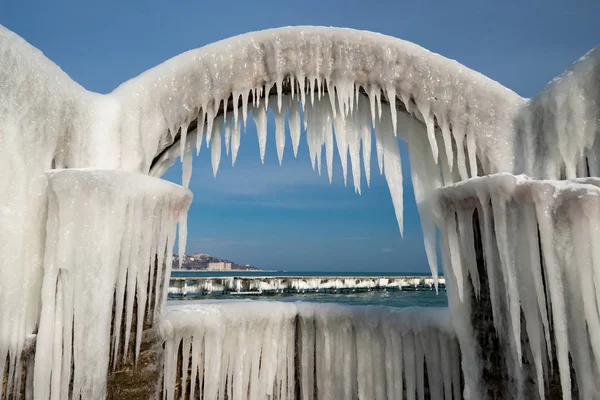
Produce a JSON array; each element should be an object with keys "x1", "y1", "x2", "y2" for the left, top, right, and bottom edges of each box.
[{"x1": 169, "y1": 276, "x2": 446, "y2": 297}]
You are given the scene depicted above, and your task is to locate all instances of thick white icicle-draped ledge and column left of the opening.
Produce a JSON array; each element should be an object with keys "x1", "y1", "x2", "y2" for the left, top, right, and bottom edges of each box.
[{"x1": 31, "y1": 169, "x2": 192, "y2": 399}]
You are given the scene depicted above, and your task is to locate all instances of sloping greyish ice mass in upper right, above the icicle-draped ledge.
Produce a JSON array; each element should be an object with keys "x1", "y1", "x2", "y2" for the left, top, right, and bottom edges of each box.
[{"x1": 512, "y1": 47, "x2": 600, "y2": 179}]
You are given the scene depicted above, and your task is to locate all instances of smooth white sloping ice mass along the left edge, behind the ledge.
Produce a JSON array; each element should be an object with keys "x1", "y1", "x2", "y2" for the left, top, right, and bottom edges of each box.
[{"x1": 0, "y1": 26, "x2": 121, "y2": 392}]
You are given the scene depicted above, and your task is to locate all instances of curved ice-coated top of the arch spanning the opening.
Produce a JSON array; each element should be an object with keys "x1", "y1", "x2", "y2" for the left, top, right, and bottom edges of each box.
[{"x1": 111, "y1": 27, "x2": 523, "y2": 177}]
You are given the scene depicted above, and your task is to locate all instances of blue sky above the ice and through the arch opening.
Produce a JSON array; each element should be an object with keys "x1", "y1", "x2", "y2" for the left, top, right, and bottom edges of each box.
[{"x1": 0, "y1": 0, "x2": 600, "y2": 271}]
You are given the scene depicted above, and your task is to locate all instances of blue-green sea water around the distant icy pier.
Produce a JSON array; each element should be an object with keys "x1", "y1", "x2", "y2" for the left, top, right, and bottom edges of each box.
[{"x1": 171, "y1": 271, "x2": 448, "y2": 307}]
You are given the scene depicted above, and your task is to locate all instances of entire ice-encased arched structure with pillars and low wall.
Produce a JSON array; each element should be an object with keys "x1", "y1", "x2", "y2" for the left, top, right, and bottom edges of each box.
[{"x1": 0, "y1": 23, "x2": 600, "y2": 400}]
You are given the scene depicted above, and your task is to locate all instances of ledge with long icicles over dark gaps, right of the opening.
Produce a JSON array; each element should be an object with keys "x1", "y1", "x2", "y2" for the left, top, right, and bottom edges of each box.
[{"x1": 437, "y1": 174, "x2": 600, "y2": 399}]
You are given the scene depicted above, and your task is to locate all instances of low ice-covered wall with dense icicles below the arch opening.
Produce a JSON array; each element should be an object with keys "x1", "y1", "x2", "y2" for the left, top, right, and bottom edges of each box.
[{"x1": 162, "y1": 301, "x2": 461, "y2": 400}]
